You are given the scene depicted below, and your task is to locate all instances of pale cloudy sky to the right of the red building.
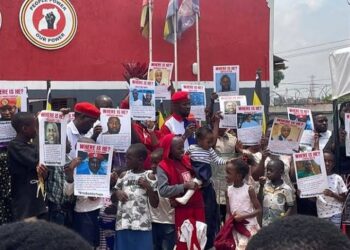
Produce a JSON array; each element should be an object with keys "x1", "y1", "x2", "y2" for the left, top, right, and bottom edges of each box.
[{"x1": 271, "y1": 0, "x2": 350, "y2": 101}]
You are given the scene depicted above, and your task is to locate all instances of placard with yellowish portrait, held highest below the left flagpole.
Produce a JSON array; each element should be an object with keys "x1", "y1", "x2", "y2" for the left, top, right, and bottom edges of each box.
[{"x1": 147, "y1": 62, "x2": 174, "y2": 100}]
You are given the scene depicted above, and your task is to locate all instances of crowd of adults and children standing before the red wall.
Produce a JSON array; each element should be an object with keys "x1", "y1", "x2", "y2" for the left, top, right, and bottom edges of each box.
[{"x1": 0, "y1": 91, "x2": 350, "y2": 250}]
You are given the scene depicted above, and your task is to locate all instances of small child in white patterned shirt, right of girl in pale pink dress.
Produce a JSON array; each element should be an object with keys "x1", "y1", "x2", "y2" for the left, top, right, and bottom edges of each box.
[{"x1": 259, "y1": 159, "x2": 294, "y2": 227}]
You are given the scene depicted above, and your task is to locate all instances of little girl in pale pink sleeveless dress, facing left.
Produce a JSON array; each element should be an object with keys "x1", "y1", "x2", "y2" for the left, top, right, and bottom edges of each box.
[{"x1": 226, "y1": 158, "x2": 261, "y2": 249}]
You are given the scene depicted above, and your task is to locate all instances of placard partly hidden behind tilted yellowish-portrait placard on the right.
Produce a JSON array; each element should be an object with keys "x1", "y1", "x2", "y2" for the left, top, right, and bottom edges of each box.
[{"x1": 287, "y1": 108, "x2": 314, "y2": 151}]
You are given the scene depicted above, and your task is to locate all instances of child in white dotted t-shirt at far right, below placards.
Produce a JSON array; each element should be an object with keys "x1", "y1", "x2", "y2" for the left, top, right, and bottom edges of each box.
[{"x1": 316, "y1": 151, "x2": 348, "y2": 228}]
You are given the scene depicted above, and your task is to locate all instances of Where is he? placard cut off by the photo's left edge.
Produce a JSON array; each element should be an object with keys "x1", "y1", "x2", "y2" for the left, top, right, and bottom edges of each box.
[{"x1": 0, "y1": 88, "x2": 27, "y2": 142}]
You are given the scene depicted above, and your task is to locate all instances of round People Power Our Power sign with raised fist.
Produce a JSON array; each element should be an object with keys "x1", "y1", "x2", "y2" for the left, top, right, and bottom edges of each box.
[{"x1": 19, "y1": 0, "x2": 77, "y2": 50}]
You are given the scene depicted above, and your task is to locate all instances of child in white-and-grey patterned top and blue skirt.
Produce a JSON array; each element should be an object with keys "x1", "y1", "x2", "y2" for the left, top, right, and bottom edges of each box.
[{"x1": 115, "y1": 143, "x2": 159, "y2": 250}]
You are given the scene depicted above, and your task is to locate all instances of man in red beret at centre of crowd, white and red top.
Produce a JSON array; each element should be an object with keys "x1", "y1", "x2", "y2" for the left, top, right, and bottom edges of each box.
[{"x1": 161, "y1": 91, "x2": 196, "y2": 150}]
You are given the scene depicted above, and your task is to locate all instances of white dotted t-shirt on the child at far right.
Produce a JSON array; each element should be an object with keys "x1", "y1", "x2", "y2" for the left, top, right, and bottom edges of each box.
[{"x1": 316, "y1": 174, "x2": 348, "y2": 218}]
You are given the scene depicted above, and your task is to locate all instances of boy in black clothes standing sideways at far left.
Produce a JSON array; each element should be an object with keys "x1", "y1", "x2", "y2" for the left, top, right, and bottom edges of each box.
[{"x1": 8, "y1": 112, "x2": 47, "y2": 221}]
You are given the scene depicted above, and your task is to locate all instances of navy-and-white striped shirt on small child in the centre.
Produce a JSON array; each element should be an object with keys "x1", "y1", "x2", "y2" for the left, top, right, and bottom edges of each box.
[{"x1": 187, "y1": 144, "x2": 227, "y2": 165}]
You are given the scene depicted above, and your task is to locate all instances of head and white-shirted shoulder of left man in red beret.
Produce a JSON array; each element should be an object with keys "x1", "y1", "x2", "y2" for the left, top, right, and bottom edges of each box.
[{"x1": 67, "y1": 102, "x2": 100, "y2": 158}]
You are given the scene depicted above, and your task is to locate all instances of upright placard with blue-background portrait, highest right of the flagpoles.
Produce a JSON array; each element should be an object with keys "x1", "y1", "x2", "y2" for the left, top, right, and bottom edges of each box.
[{"x1": 213, "y1": 65, "x2": 239, "y2": 96}]
